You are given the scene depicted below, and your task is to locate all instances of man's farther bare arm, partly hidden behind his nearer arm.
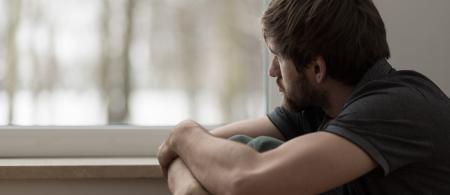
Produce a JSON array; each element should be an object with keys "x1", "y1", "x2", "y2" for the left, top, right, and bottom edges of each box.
[{"x1": 168, "y1": 117, "x2": 284, "y2": 195}]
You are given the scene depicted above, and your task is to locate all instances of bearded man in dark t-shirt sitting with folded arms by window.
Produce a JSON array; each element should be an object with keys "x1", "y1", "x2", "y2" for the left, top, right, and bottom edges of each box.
[{"x1": 158, "y1": 0, "x2": 450, "y2": 195}]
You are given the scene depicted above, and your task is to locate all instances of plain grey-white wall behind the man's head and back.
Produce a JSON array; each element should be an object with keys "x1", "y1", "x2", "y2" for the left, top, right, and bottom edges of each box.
[{"x1": 374, "y1": 0, "x2": 450, "y2": 95}]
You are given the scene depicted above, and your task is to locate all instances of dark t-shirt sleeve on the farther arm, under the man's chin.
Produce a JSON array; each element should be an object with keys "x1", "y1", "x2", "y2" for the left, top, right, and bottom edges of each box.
[{"x1": 267, "y1": 107, "x2": 325, "y2": 140}]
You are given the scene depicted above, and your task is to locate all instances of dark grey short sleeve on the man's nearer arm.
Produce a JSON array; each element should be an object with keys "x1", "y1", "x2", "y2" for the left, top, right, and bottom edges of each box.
[{"x1": 324, "y1": 84, "x2": 433, "y2": 175}]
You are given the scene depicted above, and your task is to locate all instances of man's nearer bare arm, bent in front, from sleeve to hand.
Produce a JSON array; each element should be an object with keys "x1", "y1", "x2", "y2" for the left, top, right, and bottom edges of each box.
[{"x1": 162, "y1": 122, "x2": 376, "y2": 194}]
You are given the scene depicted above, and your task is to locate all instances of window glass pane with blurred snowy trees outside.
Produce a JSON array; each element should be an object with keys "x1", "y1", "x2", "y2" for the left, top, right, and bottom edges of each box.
[{"x1": 0, "y1": 0, "x2": 265, "y2": 125}]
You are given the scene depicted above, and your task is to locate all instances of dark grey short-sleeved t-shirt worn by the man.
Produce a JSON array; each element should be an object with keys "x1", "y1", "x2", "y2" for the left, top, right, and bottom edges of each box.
[{"x1": 268, "y1": 60, "x2": 450, "y2": 195}]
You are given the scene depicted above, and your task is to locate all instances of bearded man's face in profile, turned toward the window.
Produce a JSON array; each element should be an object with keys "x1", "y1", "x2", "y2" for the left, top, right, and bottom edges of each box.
[{"x1": 267, "y1": 39, "x2": 321, "y2": 112}]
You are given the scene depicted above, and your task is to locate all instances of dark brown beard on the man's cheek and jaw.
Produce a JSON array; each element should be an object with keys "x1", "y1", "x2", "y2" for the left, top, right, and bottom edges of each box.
[{"x1": 283, "y1": 73, "x2": 327, "y2": 112}]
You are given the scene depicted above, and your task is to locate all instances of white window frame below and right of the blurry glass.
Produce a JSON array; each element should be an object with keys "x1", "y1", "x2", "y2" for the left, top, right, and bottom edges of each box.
[{"x1": 0, "y1": 0, "x2": 280, "y2": 158}]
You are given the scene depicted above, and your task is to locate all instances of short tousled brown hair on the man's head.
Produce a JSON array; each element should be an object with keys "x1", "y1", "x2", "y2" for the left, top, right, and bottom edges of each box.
[{"x1": 262, "y1": 0, "x2": 390, "y2": 85}]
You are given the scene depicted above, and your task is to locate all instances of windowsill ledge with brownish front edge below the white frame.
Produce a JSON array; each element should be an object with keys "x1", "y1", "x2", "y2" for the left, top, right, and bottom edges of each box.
[{"x1": 0, "y1": 157, "x2": 162, "y2": 180}]
